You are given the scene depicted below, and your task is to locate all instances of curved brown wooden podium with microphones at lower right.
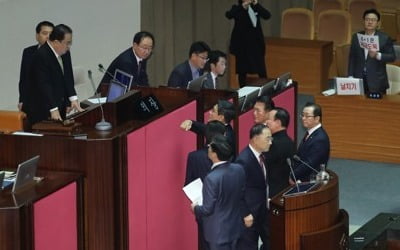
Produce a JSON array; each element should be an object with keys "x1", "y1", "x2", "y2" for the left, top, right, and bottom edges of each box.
[{"x1": 269, "y1": 171, "x2": 349, "y2": 250}]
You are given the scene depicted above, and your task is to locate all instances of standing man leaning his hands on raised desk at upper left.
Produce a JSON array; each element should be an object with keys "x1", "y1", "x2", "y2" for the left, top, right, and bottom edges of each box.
[{"x1": 23, "y1": 24, "x2": 83, "y2": 124}]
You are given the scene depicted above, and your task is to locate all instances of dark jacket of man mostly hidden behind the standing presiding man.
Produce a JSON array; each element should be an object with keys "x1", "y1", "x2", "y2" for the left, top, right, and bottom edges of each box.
[{"x1": 18, "y1": 44, "x2": 39, "y2": 103}]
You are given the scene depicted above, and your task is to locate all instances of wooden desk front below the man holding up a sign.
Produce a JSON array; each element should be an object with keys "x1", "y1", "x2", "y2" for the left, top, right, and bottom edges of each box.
[{"x1": 316, "y1": 95, "x2": 400, "y2": 163}]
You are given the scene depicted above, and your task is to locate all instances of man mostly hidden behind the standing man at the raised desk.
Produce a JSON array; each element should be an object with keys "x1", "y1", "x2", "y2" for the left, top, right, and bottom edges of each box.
[{"x1": 18, "y1": 21, "x2": 54, "y2": 110}]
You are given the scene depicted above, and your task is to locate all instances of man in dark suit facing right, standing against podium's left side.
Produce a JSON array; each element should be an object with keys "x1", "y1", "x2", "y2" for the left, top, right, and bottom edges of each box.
[{"x1": 235, "y1": 124, "x2": 272, "y2": 250}]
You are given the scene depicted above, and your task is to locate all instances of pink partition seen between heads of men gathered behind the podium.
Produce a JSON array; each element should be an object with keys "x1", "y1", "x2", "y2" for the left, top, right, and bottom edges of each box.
[{"x1": 239, "y1": 86, "x2": 297, "y2": 152}]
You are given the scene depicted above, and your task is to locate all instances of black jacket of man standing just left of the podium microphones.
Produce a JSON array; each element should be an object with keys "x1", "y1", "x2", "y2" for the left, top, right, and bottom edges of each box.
[{"x1": 264, "y1": 130, "x2": 295, "y2": 198}]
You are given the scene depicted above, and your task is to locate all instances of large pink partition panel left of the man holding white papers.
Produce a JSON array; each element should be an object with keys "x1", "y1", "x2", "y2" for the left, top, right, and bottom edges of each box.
[{"x1": 127, "y1": 101, "x2": 197, "y2": 250}]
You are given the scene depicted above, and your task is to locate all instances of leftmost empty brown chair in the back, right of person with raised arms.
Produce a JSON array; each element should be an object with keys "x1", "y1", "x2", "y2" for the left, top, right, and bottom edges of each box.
[{"x1": 281, "y1": 8, "x2": 314, "y2": 40}]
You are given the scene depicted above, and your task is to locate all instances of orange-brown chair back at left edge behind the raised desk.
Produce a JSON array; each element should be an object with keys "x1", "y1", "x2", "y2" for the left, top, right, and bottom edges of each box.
[{"x1": 0, "y1": 110, "x2": 26, "y2": 134}]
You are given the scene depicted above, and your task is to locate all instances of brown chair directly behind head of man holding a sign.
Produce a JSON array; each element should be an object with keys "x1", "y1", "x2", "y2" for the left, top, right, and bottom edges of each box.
[{"x1": 347, "y1": 0, "x2": 377, "y2": 33}]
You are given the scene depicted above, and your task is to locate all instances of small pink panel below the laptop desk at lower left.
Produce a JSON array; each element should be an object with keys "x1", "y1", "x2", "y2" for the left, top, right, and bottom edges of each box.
[{"x1": 33, "y1": 183, "x2": 78, "y2": 250}]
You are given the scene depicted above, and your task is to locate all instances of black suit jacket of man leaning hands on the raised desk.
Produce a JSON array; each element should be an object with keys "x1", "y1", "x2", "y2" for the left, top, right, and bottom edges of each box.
[{"x1": 22, "y1": 43, "x2": 76, "y2": 124}]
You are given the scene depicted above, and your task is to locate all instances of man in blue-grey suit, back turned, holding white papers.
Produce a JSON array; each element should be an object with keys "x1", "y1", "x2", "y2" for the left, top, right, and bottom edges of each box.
[{"x1": 192, "y1": 135, "x2": 245, "y2": 250}]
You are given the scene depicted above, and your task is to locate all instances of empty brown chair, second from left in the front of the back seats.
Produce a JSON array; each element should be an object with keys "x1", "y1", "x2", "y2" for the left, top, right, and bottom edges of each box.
[{"x1": 317, "y1": 10, "x2": 351, "y2": 48}]
